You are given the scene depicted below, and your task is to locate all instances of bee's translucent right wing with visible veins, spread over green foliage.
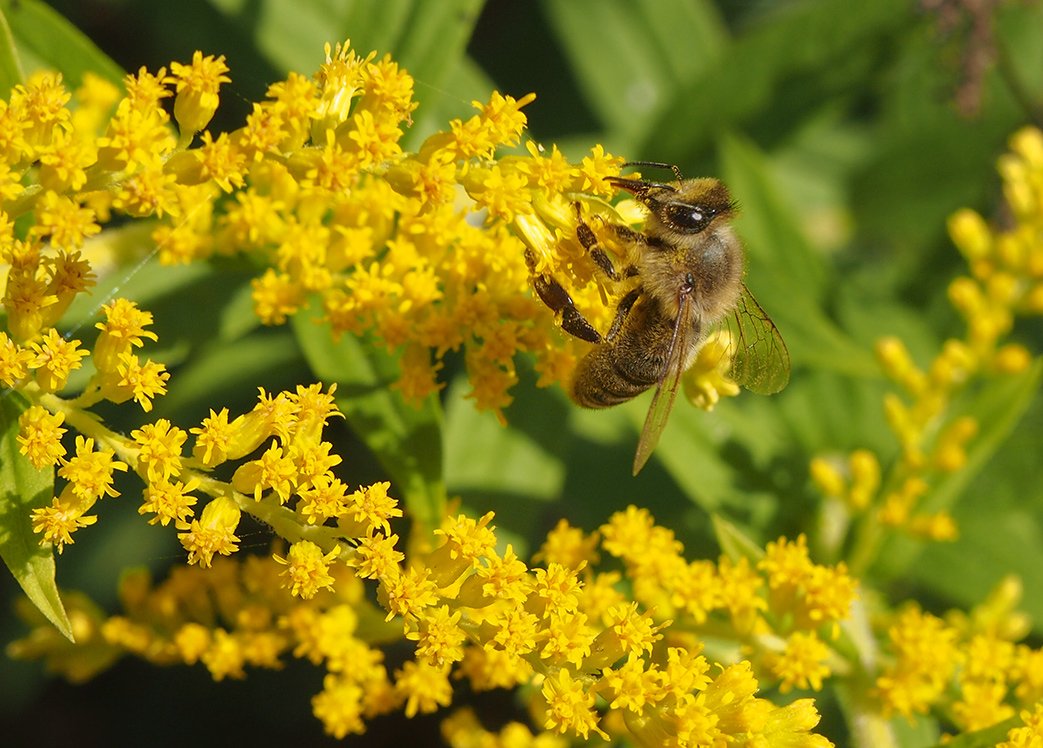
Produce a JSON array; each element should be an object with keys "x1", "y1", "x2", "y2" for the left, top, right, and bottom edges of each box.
[{"x1": 725, "y1": 284, "x2": 790, "y2": 394}]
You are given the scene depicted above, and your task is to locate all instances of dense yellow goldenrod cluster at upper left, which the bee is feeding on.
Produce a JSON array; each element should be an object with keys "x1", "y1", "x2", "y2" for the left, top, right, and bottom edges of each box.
[{"x1": 0, "y1": 44, "x2": 622, "y2": 431}]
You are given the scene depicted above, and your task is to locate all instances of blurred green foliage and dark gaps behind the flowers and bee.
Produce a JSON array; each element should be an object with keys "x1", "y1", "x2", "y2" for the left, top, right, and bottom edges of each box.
[{"x1": 0, "y1": 0, "x2": 1043, "y2": 745}]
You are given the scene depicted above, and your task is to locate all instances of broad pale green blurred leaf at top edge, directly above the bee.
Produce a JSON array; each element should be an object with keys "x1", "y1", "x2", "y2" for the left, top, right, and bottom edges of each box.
[{"x1": 541, "y1": 0, "x2": 726, "y2": 150}]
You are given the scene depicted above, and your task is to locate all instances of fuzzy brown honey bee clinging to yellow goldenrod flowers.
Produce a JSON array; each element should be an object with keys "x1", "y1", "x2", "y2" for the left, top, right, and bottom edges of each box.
[{"x1": 529, "y1": 162, "x2": 790, "y2": 475}]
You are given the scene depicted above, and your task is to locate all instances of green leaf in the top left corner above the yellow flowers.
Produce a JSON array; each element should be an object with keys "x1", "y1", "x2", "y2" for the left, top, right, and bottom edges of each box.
[{"x1": 0, "y1": 0, "x2": 124, "y2": 89}]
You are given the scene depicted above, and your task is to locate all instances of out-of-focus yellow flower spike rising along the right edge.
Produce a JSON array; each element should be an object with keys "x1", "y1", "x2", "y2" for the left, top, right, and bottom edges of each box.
[{"x1": 811, "y1": 128, "x2": 1043, "y2": 555}]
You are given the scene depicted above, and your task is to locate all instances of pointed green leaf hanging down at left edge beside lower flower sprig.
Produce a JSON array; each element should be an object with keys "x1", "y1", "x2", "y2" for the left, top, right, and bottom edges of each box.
[{"x1": 0, "y1": 390, "x2": 73, "y2": 642}]
